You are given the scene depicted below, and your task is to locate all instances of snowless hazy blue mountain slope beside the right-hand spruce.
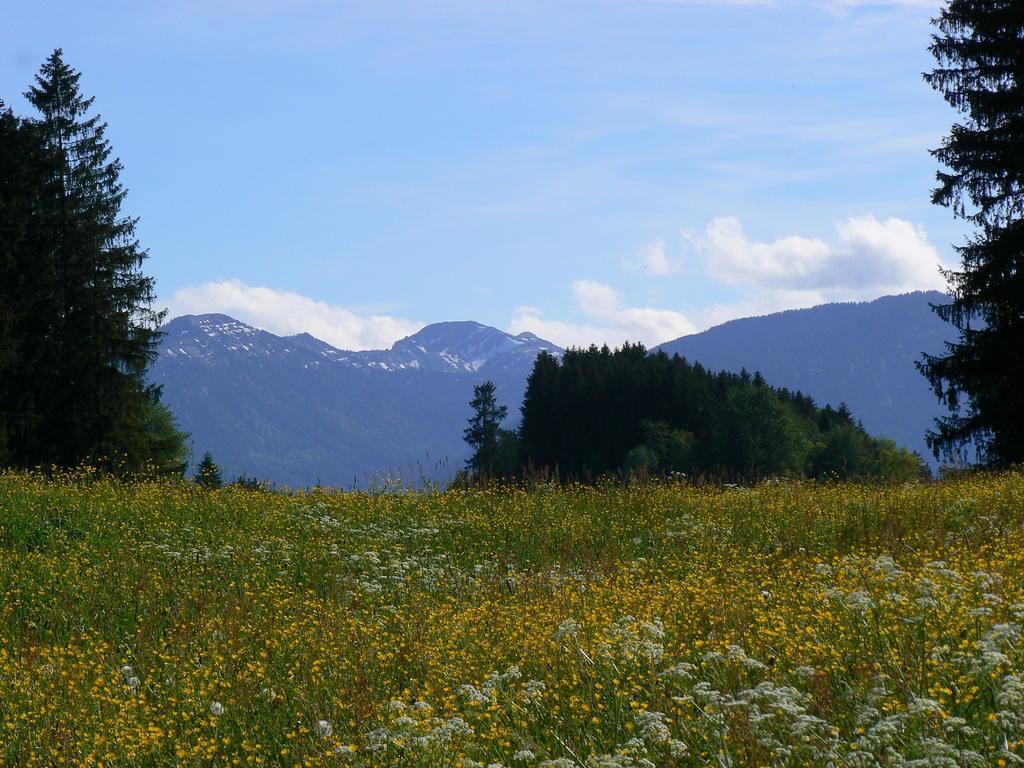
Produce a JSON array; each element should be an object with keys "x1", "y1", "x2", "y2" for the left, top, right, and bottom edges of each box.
[{"x1": 659, "y1": 292, "x2": 953, "y2": 460}]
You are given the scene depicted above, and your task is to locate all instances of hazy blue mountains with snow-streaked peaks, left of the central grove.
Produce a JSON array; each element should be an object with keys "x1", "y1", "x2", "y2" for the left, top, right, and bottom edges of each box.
[{"x1": 150, "y1": 314, "x2": 559, "y2": 485}]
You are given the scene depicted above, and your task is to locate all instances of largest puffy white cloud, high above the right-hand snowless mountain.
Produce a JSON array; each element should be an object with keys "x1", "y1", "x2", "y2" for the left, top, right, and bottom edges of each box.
[{"x1": 695, "y1": 216, "x2": 945, "y2": 301}]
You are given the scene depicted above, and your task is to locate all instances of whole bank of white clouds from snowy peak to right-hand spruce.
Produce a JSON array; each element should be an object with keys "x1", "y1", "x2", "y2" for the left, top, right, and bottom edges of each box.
[{"x1": 511, "y1": 216, "x2": 946, "y2": 346}]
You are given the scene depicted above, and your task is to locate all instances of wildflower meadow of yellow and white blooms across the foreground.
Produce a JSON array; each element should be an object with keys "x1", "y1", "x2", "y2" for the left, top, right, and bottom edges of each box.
[{"x1": 0, "y1": 473, "x2": 1024, "y2": 768}]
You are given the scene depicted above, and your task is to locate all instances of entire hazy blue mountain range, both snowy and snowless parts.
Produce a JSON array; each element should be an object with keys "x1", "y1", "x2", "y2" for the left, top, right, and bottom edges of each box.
[{"x1": 150, "y1": 293, "x2": 949, "y2": 486}]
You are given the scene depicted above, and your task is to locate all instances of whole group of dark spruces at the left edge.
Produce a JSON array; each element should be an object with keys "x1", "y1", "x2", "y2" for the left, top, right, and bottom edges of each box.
[{"x1": 0, "y1": 49, "x2": 185, "y2": 472}]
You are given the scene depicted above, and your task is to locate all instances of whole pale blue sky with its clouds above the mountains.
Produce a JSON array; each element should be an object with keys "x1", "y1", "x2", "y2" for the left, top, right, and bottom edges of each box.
[{"x1": 0, "y1": 0, "x2": 964, "y2": 348}]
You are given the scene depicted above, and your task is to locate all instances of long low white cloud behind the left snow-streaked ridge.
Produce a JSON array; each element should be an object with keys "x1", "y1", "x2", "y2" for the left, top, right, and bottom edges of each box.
[{"x1": 169, "y1": 280, "x2": 423, "y2": 350}]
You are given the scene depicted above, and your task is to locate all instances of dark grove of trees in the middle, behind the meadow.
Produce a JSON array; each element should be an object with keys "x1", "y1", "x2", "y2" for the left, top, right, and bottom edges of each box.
[{"x1": 467, "y1": 344, "x2": 928, "y2": 480}]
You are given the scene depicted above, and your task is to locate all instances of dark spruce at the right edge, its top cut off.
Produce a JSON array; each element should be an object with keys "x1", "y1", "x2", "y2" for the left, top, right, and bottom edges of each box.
[{"x1": 919, "y1": 0, "x2": 1024, "y2": 466}]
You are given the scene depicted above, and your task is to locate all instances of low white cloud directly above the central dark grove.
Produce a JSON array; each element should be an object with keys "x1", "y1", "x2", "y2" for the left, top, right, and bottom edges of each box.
[{"x1": 510, "y1": 280, "x2": 697, "y2": 346}]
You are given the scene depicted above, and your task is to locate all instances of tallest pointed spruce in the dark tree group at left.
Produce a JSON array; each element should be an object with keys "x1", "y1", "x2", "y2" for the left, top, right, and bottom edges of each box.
[{"x1": 25, "y1": 48, "x2": 181, "y2": 470}]
